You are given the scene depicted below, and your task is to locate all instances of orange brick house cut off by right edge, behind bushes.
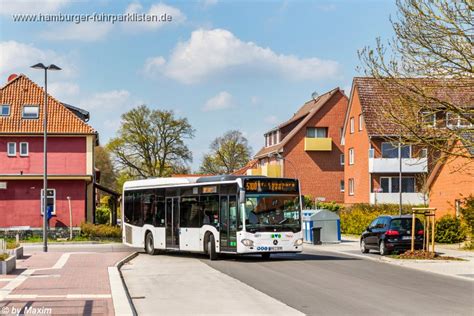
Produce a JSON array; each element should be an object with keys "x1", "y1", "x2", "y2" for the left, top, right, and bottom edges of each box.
[{"x1": 428, "y1": 131, "x2": 474, "y2": 218}]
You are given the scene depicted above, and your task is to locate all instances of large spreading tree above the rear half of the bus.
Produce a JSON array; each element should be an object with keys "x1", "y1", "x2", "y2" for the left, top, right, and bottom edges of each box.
[{"x1": 107, "y1": 105, "x2": 194, "y2": 178}]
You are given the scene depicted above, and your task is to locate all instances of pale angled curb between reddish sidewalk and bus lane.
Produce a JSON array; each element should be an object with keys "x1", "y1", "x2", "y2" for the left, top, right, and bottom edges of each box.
[{"x1": 108, "y1": 252, "x2": 138, "y2": 316}]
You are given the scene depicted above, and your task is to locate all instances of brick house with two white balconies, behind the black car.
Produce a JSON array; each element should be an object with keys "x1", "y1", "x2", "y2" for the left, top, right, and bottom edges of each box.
[{"x1": 343, "y1": 78, "x2": 473, "y2": 205}]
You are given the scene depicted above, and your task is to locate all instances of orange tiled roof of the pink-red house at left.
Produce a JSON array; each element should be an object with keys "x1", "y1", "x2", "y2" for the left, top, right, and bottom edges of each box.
[{"x1": 0, "y1": 75, "x2": 96, "y2": 134}]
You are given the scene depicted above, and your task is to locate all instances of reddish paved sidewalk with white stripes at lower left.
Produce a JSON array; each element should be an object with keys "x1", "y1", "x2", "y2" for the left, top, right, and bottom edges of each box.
[{"x1": 0, "y1": 246, "x2": 130, "y2": 315}]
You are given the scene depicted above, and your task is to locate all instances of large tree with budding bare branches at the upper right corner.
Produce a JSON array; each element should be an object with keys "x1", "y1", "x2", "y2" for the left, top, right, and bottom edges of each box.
[{"x1": 359, "y1": 0, "x2": 474, "y2": 162}]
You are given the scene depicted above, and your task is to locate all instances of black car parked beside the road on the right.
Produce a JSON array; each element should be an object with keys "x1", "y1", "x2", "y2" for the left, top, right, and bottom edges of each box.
[{"x1": 360, "y1": 215, "x2": 423, "y2": 256}]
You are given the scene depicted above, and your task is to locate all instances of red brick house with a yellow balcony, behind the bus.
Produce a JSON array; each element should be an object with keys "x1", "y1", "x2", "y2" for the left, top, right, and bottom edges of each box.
[{"x1": 252, "y1": 88, "x2": 348, "y2": 202}]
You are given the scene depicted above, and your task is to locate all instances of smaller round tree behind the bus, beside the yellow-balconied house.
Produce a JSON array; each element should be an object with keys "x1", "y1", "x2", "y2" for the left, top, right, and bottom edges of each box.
[{"x1": 200, "y1": 130, "x2": 252, "y2": 174}]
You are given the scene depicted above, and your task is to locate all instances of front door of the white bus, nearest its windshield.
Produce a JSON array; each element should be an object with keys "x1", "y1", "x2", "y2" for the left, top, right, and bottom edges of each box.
[{"x1": 219, "y1": 195, "x2": 237, "y2": 251}]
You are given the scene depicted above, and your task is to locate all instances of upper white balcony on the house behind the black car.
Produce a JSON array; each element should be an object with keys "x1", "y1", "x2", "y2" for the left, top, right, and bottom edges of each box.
[{"x1": 369, "y1": 149, "x2": 428, "y2": 173}]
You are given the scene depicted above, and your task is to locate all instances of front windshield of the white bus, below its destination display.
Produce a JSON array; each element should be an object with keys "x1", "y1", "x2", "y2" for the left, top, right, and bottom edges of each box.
[{"x1": 245, "y1": 194, "x2": 301, "y2": 233}]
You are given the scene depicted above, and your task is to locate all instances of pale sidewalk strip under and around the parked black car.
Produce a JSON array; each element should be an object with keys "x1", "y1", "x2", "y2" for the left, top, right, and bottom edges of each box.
[{"x1": 303, "y1": 237, "x2": 474, "y2": 282}]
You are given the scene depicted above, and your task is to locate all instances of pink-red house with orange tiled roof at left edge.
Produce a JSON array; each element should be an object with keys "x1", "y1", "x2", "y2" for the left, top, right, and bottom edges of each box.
[{"x1": 0, "y1": 75, "x2": 98, "y2": 228}]
